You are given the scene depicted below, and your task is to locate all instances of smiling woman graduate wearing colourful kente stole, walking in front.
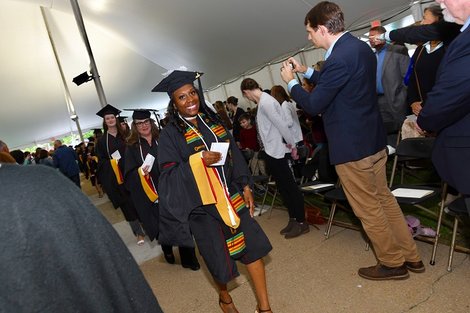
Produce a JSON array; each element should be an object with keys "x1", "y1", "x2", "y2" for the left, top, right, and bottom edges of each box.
[{"x1": 153, "y1": 71, "x2": 272, "y2": 312}]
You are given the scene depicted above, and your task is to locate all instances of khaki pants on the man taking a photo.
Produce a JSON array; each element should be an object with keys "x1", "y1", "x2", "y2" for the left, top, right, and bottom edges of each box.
[{"x1": 336, "y1": 150, "x2": 421, "y2": 267}]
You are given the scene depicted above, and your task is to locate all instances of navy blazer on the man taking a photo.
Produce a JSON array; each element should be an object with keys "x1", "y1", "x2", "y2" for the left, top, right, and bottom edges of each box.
[{"x1": 291, "y1": 33, "x2": 386, "y2": 164}]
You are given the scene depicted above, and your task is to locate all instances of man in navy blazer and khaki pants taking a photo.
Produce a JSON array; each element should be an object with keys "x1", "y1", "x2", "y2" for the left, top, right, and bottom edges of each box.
[{"x1": 281, "y1": 1, "x2": 425, "y2": 280}]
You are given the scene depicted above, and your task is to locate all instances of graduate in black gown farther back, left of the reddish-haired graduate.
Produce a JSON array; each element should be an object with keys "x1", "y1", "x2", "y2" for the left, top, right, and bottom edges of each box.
[{"x1": 95, "y1": 104, "x2": 145, "y2": 245}]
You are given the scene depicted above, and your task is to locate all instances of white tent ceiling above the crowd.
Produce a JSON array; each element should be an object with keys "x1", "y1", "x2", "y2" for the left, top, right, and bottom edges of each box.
[{"x1": 0, "y1": 0, "x2": 410, "y2": 148}]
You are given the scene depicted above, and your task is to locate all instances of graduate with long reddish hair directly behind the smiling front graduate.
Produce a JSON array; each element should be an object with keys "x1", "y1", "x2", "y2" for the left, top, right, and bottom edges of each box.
[{"x1": 124, "y1": 110, "x2": 200, "y2": 271}]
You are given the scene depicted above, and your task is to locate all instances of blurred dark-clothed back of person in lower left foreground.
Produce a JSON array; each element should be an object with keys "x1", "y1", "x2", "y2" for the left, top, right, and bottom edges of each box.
[{"x1": 0, "y1": 164, "x2": 162, "y2": 313}]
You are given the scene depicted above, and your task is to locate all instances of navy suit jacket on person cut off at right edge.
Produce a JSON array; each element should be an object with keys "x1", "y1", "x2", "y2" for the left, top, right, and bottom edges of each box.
[{"x1": 418, "y1": 27, "x2": 470, "y2": 195}]
